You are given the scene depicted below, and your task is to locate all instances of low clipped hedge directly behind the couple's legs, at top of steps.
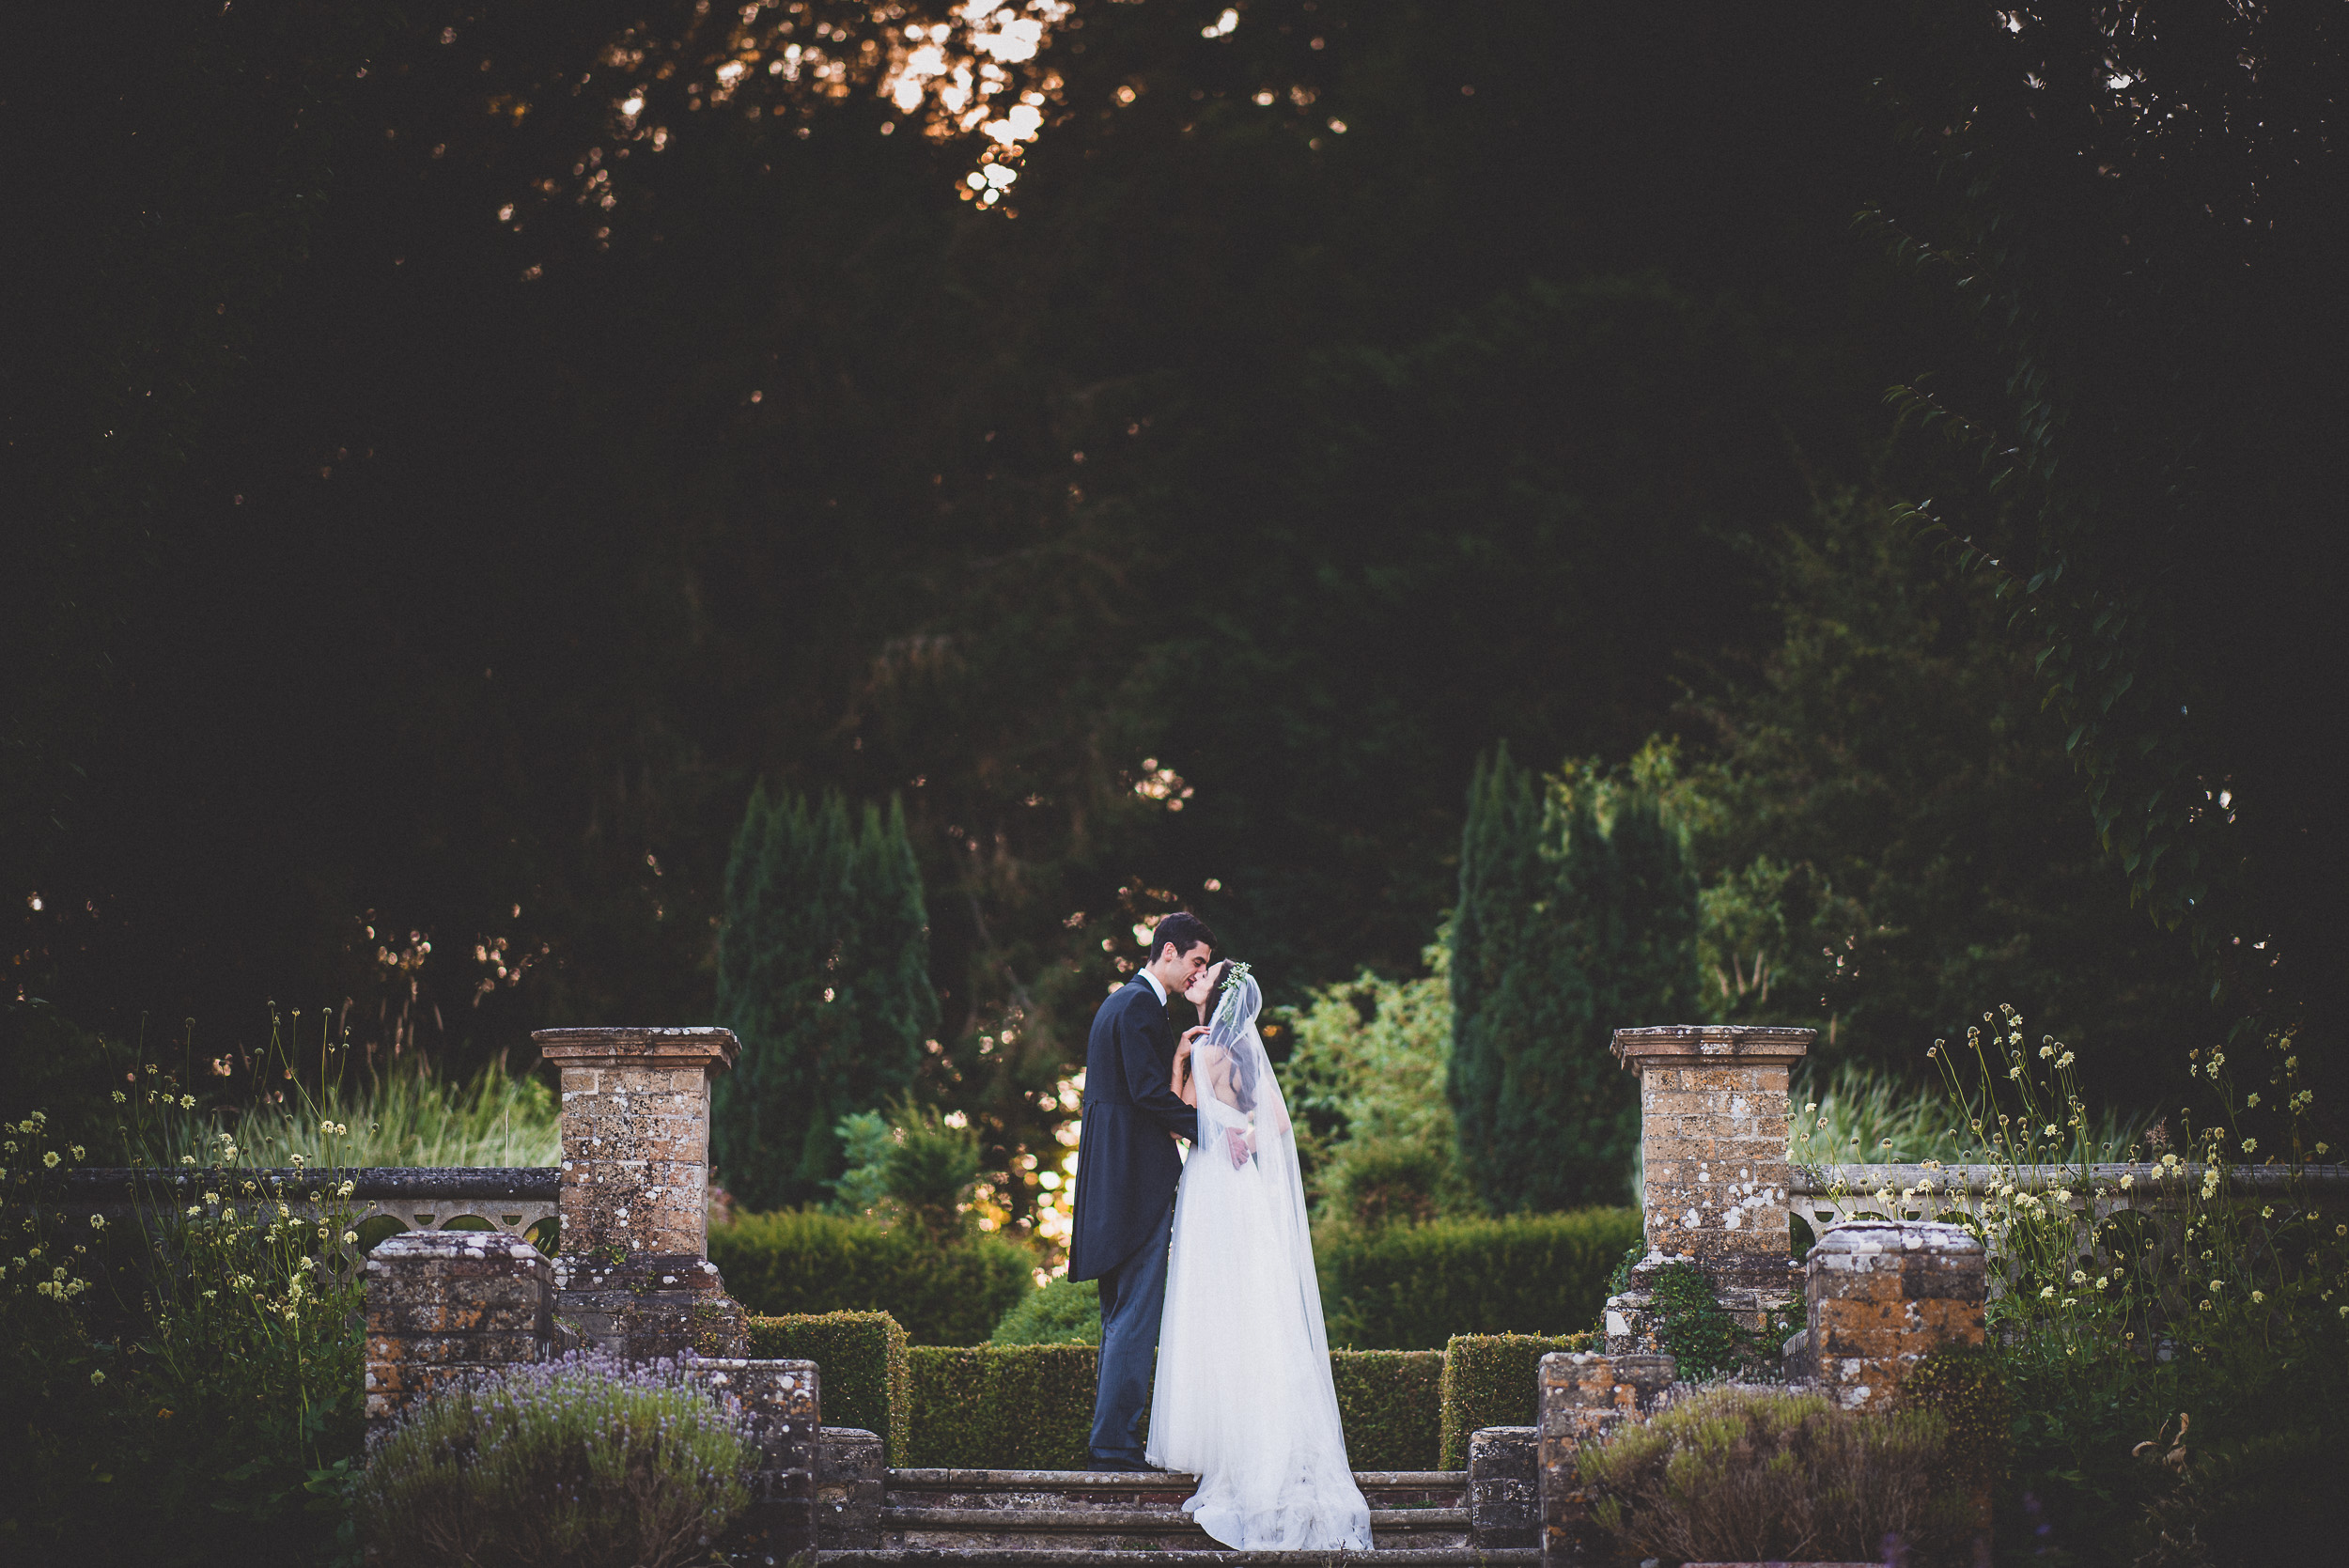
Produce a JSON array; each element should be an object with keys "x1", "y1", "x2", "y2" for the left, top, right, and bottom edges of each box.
[{"x1": 897, "y1": 1345, "x2": 1445, "y2": 1469}]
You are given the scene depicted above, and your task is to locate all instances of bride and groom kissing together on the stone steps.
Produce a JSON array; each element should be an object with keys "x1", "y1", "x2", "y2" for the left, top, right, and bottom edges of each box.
[{"x1": 1069, "y1": 913, "x2": 1370, "y2": 1552}]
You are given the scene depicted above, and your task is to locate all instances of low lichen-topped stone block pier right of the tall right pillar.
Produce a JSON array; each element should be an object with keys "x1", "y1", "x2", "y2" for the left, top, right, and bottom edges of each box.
[{"x1": 1802, "y1": 1220, "x2": 1990, "y2": 1411}]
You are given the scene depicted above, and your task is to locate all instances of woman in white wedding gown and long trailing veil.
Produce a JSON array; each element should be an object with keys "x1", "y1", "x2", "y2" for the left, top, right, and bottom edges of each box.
[{"x1": 1149, "y1": 962, "x2": 1370, "y2": 1552}]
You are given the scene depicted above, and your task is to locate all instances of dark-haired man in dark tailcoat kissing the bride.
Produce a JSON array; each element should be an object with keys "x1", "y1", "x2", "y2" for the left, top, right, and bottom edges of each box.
[{"x1": 1069, "y1": 913, "x2": 1215, "y2": 1469}]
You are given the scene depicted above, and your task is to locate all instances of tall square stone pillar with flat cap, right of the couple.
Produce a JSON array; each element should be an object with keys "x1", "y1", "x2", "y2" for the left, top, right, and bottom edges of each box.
[{"x1": 1605, "y1": 1023, "x2": 1818, "y2": 1355}]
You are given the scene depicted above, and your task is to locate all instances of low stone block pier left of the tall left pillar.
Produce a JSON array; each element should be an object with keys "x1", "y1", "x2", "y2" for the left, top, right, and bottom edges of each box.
[{"x1": 365, "y1": 1230, "x2": 554, "y2": 1446}]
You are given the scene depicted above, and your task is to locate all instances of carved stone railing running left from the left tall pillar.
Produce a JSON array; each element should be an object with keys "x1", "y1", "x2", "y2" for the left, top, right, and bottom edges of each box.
[{"x1": 45, "y1": 1164, "x2": 562, "y2": 1242}]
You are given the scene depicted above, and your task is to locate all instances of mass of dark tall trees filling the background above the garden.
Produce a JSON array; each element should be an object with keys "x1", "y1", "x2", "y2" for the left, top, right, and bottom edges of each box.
[{"x1": 0, "y1": 0, "x2": 2349, "y2": 1197}]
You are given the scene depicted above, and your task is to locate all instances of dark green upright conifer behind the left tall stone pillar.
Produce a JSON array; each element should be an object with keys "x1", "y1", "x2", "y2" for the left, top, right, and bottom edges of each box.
[{"x1": 709, "y1": 786, "x2": 938, "y2": 1209}]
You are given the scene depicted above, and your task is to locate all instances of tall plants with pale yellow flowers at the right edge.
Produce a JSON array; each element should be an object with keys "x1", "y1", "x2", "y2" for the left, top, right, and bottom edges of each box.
[{"x1": 1934, "y1": 1007, "x2": 2349, "y2": 1563}]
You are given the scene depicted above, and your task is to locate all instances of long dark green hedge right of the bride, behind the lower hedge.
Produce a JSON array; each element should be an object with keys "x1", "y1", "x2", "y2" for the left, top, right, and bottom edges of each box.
[{"x1": 1314, "y1": 1209, "x2": 1640, "y2": 1350}]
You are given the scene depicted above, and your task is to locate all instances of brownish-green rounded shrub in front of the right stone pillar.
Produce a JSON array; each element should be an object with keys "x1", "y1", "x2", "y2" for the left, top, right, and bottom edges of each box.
[{"x1": 1577, "y1": 1388, "x2": 1971, "y2": 1563}]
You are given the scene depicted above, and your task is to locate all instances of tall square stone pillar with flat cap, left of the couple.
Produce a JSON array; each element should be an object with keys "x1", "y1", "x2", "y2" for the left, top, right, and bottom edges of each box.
[{"x1": 531, "y1": 1028, "x2": 747, "y2": 1359}]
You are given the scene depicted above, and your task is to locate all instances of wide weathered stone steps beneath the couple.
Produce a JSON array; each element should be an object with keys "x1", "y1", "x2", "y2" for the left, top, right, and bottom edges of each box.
[{"x1": 817, "y1": 1469, "x2": 1539, "y2": 1568}]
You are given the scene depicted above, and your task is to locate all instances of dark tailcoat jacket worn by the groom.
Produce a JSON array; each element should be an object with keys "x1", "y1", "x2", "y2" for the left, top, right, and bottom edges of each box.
[{"x1": 1069, "y1": 974, "x2": 1198, "y2": 1280}]
